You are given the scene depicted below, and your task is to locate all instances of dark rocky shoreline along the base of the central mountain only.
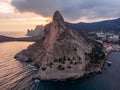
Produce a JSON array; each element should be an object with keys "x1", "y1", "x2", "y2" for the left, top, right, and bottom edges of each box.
[{"x1": 32, "y1": 60, "x2": 106, "y2": 82}]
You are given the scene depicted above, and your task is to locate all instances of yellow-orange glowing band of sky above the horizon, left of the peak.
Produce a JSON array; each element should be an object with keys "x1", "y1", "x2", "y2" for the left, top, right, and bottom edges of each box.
[{"x1": 0, "y1": 13, "x2": 51, "y2": 32}]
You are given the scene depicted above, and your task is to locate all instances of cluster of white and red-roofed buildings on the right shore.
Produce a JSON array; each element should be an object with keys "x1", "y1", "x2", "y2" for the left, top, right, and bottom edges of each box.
[{"x1": 96, "y1": 31, "x2": 120, "y2": 51}]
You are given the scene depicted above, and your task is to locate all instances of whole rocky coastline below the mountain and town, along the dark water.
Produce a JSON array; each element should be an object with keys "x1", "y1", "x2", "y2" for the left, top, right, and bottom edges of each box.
[{"x1": 13, "y1": 40, "x2": 120, "y2": 81}]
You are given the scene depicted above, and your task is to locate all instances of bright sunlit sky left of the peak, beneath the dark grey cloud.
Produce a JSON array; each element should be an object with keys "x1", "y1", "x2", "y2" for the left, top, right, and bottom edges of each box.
[{"x1": 0, "y1": 0, "x2": 51, "y2": 32}]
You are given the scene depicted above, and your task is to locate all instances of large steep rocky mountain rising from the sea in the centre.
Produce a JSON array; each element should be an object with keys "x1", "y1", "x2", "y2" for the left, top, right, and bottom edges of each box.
[{"x1": 15, "y1": 11, "x2": 105, "y2": 80}]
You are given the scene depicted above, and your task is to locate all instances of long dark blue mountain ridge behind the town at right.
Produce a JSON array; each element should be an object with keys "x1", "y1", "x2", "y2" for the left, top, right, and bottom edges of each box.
[{"x1": 66, "y1": 18, "x2": 120, "y2": 33}]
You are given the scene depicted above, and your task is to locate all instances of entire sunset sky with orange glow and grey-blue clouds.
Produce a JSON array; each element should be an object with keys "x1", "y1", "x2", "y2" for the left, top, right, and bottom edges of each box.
[{"x1": 0, "y1": 0, "x2": 120, "y2": 32}]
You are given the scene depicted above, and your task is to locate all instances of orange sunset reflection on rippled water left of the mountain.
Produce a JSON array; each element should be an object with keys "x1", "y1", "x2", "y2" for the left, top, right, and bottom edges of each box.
[{"x1": 0, "y1": 42, "x2": 34, "y2": 90}]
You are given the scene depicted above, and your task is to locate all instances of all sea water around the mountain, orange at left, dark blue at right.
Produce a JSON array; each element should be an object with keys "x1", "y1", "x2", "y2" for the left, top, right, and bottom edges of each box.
[{"x1": 0, "y1": 42, "x2": 120, "y2": 90}]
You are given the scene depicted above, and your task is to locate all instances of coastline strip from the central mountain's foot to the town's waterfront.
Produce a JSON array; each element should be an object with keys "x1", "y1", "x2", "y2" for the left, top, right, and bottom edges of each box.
[{"x1": 33, "y1": 44, "x2": 120, "y2": 82}]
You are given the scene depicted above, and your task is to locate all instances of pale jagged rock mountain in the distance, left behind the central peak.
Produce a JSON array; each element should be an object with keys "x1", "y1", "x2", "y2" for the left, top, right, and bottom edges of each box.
[{"x1": 26, "y1": 25, "x2": 44, "y2": 36}]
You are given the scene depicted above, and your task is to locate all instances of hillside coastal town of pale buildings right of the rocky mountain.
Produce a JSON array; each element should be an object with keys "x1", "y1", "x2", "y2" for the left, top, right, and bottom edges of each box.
[{"x1": 85, "y1": 31, "x2": 120, "y2": 54}]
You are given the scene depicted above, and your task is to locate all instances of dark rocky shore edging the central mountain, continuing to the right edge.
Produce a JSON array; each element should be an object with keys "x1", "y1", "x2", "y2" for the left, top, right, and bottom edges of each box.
[{"x1": 29, "y1": 44, "x2": 120, "y2": 82}]
